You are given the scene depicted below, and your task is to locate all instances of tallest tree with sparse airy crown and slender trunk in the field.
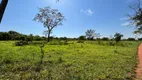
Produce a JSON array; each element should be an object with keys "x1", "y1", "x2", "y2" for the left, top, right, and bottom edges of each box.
[{"x1": 34, "y1": 7, "x2": 65, "y2": 42}]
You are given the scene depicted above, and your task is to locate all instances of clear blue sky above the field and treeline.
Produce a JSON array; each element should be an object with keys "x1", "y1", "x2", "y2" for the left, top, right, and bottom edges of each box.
[{"x1": 0, "y1": 0, "x2": 140, "y2": 38}]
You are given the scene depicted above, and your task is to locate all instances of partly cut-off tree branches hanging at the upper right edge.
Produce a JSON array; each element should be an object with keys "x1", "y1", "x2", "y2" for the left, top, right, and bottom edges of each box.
[{"x1": 128, "y1": 0, "x2": 142, "y2": 34}]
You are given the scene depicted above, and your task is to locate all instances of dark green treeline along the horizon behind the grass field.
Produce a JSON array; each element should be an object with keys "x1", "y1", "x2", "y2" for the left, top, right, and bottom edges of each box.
[{"x1": 0, "y1": 31, "x2": 142, "y2": 41}]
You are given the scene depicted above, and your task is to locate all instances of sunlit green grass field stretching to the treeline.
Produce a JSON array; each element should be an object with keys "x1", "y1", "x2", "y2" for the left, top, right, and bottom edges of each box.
[{"x1": 0, "y1": 41, "x2": 139, "y2": 80}]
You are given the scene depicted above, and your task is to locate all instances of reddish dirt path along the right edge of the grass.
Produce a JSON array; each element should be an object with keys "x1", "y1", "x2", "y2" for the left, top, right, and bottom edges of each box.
[{"x1": 136, "y1": 43, "x2": 142, "y2": 80}]
